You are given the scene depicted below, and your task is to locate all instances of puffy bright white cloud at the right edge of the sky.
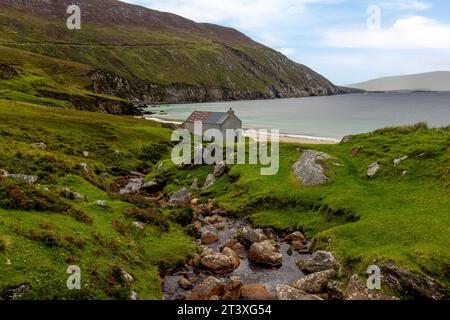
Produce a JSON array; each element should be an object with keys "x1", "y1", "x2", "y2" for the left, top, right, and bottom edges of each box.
[{"x1": 323, "y1": 16, "x2": 450, "y2": 50}]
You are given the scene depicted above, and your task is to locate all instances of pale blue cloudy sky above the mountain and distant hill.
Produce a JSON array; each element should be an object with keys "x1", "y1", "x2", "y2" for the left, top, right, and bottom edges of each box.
[{"x1": 125, "y1": 0, "x2": 450, "y2": 85}]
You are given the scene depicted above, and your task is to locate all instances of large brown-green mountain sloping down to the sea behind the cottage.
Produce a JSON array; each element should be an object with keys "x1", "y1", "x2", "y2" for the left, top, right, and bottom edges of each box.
[{"x1": 0, "y1": 0, "x2": 353, "y2": 109}]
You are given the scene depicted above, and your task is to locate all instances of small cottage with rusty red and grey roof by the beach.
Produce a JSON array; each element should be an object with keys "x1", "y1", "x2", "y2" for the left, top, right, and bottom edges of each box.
[{"x1": 184, "y1": 108, "x2": 242, "y2": 142}]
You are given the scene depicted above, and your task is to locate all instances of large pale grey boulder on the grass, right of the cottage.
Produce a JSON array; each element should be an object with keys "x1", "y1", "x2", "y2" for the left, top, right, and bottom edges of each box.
[{"x1": 292, "y1": 150, "x2": 331, "y2": 186}]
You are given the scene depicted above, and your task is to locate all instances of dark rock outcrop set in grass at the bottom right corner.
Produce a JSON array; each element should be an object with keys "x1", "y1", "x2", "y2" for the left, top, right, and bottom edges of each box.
[{"x1": 380, "y1": 265, "x2": 445, "y2": 300}]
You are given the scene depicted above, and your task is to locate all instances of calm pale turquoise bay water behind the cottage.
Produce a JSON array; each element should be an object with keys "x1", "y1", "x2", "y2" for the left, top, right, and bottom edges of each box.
[{"x1": 144, "y1": 92, "x2": 450, "y2": 139}]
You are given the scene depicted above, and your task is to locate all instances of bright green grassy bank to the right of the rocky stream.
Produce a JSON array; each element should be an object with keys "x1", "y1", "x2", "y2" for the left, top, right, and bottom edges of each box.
[{"x1": 156, "y1": 126, "x2": 450, "y2": 292}]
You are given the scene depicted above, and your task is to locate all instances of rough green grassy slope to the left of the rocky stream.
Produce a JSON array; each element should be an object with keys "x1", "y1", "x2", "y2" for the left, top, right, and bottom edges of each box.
[{"x1": 0, "y1": 100, "x2": 195, "y2": 299}]
